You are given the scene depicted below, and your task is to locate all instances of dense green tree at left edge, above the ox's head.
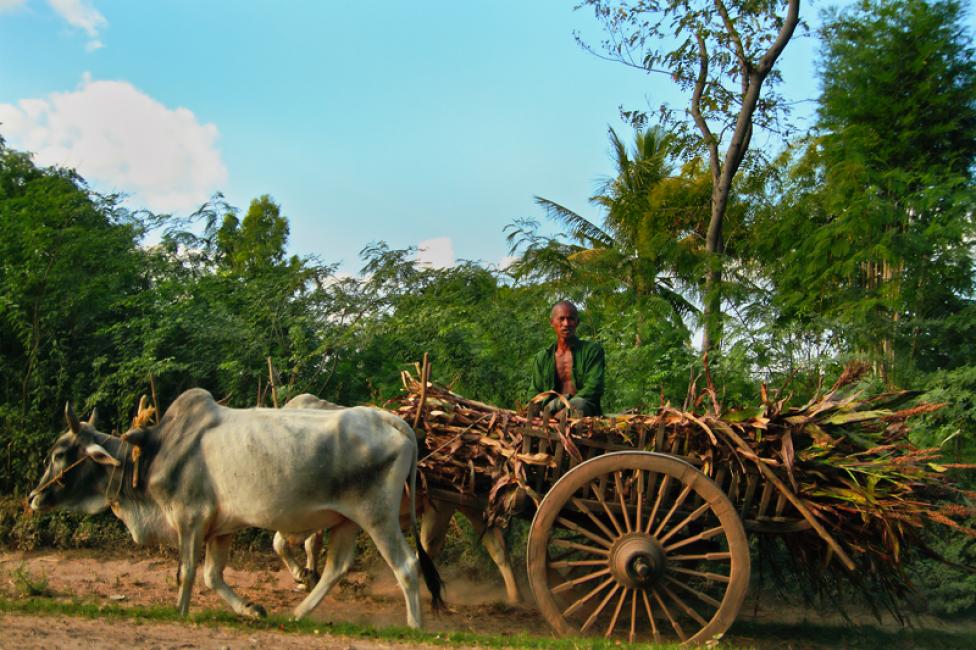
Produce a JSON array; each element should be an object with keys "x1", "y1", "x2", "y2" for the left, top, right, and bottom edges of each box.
[{"x1": 0, "y1": 142, "x2": 142, "y2": 491}]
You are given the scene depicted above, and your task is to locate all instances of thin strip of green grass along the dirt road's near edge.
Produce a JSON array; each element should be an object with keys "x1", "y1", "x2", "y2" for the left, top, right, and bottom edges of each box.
[{"x1": 0, "y1": 597, "x2": 677, "y2": 650}]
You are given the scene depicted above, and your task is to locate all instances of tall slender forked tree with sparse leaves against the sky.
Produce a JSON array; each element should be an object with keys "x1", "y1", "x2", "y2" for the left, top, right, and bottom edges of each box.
[{"x1": 580, "y1": 0, "x2": 800, "y2": 352}]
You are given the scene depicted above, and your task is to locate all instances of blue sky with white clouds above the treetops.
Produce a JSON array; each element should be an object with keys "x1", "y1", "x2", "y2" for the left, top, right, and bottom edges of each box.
[{"x1": 0, "y1": 0, "x2": 900, "y2": 271}]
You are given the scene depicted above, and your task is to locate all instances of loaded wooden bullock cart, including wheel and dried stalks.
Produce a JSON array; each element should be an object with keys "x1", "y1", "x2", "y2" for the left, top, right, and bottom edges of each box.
[{"x1": 397, "y1": 367, "x2": 964, "y2": 645}]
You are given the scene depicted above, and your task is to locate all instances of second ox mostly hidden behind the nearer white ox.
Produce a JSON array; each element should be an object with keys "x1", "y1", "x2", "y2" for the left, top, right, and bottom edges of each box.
[{"x1": 274, "y1": 393, "x2": 521, "y2": 604}]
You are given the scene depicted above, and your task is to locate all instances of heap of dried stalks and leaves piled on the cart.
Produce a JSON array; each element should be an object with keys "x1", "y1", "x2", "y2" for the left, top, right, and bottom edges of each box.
[{"x1": 394, "y1": 360, "x2": 976, "y2": 597}]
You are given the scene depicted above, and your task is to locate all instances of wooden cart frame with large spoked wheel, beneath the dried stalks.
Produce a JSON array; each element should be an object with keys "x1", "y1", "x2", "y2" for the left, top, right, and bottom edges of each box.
[{"x1": 429, "y1": 404, "x2": 811, "y2": 644}]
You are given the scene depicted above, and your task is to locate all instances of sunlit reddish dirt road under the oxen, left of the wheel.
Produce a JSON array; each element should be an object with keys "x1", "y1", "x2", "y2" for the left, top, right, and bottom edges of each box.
[{"x1": 0, "y1": 551, "x2": 548, "y2": 650}]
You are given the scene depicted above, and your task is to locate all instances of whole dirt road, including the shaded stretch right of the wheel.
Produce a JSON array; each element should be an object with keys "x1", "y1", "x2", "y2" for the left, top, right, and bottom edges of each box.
[{"x1": 0, "y1": 549, "x2": 976, "y2": 650}]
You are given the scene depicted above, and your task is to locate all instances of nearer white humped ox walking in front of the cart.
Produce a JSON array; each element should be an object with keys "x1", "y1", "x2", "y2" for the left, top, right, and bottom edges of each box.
[{"x1": 29, "y1": 389, "x2": 441, "y2": 627}]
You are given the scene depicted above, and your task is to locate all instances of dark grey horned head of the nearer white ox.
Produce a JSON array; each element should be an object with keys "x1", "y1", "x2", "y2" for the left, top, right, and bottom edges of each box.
[{"x1": 28, "y1": 402, "x2": 121, "y2": 514}]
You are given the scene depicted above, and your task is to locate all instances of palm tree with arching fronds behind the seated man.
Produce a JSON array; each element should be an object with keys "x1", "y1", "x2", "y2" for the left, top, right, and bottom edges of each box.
[{"x1": 508, "y1": 127, "x2": 702, "y2": 330}]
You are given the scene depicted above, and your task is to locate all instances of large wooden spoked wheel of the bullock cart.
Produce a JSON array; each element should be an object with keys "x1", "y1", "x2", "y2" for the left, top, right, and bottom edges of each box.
[{"x1": 527, "y1": 451, "x2": 749, "y2": 644}]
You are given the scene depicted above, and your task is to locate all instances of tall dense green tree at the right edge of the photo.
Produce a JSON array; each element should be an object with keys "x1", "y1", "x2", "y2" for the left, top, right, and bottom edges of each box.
[{"x1": 756, "y1": 0, "x2": 976, "y2": 383}]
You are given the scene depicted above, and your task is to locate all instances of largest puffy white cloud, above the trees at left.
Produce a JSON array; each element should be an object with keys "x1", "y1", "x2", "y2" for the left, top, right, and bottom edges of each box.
[{"x1": 0, "y1": 74, "x2": 227, "y2": 212}]
